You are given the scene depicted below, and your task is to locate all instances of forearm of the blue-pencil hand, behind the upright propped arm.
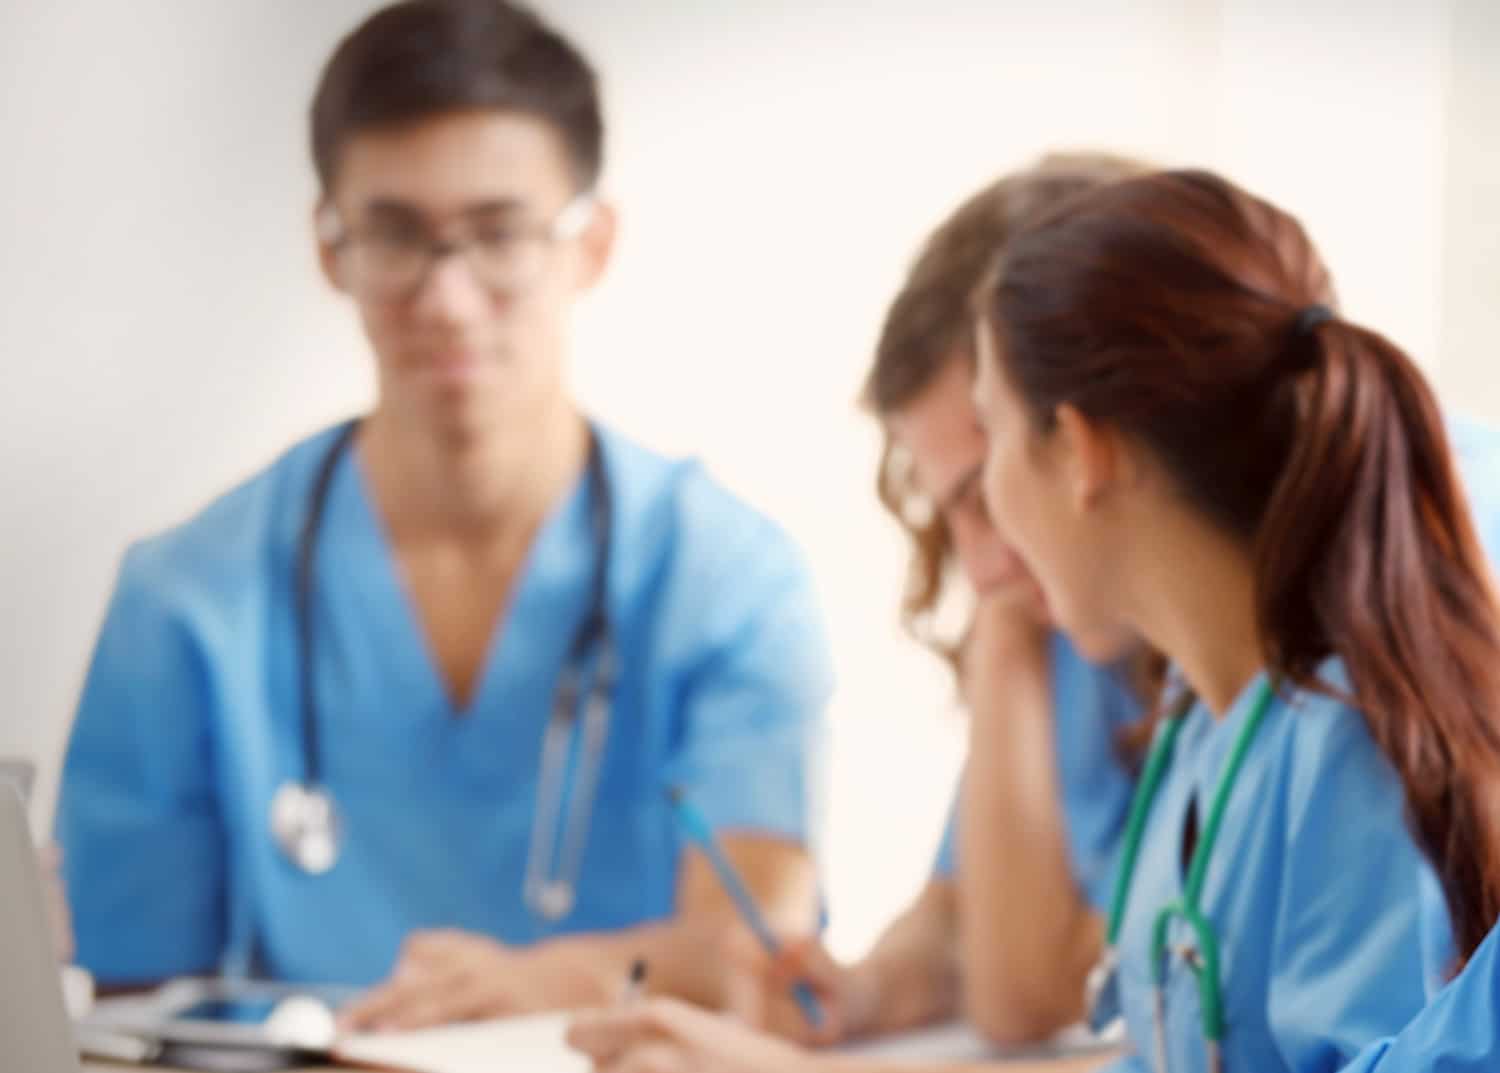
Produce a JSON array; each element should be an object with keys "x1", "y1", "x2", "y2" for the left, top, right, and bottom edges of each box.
[{"x1": 852, "y1": 879, "x2": 960, "y2": 1035}]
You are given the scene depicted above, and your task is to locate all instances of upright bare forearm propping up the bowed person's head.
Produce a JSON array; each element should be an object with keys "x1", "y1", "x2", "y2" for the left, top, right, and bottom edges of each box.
[{"x1": 959, "y1": 621, "x2": 1103, "y2": 1043}]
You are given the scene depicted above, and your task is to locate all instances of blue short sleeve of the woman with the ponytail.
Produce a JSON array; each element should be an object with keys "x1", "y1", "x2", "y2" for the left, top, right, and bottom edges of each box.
[{"x1": 1269, "y1": 708, "x2": 1433, "y2": 1073}]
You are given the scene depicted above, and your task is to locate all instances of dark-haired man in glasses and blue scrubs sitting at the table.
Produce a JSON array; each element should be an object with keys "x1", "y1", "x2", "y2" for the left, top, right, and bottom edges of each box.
[{"x1": 59, "y1": 0, "x2": 831, "y2": 1026}]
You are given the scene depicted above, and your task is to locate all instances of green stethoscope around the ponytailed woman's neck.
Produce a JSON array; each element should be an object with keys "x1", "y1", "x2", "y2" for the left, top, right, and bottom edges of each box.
[{"x1": 1089, "y1": 678, "x2": 1277, "y2": 1073}]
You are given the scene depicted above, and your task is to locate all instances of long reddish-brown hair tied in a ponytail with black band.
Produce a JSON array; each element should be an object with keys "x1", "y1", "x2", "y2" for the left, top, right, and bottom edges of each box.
[{"x1": 983, "y1": 171, "x2": 1500, "y2": 956}]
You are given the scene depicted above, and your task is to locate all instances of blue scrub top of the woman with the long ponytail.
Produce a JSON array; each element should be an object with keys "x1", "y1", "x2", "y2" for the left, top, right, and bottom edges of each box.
[{"x1": 1112, "y1": 660, "x2": 1451, "y2": 1073}]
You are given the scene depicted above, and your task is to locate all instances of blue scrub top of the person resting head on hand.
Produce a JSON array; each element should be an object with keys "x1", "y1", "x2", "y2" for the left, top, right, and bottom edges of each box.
[{"x1": 933, "y1": 632, "x2": 1143, "y2": 909}]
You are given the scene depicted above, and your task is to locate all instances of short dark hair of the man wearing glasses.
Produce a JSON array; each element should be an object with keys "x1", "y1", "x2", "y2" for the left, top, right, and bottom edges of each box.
[{"x1": 312, "y1": 0, "x2": 605, "y2": 192}]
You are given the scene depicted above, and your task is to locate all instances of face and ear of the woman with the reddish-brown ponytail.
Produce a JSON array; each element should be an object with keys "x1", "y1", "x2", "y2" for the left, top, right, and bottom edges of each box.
[{"x1": 974, "y1": 324, "x2": 1133, "y2": 659}]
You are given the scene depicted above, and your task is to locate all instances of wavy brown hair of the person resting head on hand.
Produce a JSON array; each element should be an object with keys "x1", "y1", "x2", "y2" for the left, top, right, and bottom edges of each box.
[{"x1": 864, "y1": 153, "x2": 1148, "y2": 668}]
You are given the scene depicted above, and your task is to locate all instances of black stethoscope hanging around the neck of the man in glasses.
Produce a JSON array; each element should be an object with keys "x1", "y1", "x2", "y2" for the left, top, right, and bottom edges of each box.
[{"x1": 270, "y1": 420, "x2": 620, "y2": 921}]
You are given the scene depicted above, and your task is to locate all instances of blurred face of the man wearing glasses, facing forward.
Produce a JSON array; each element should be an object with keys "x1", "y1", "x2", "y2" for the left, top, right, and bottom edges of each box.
[{"x1": 318, "y1": 111, "x2": 612, "y2": 438}]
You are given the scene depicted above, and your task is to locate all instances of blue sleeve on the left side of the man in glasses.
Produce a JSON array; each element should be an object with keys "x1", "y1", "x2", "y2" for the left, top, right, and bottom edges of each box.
[{"x1": 57, "y1": 552, "x2": 227, "y2": 983}]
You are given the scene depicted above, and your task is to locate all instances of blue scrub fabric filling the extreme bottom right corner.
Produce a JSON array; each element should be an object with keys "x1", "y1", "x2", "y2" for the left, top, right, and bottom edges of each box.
[{"x1": 1341, "y1": 927, "x2": 1500, "y2": 1073}]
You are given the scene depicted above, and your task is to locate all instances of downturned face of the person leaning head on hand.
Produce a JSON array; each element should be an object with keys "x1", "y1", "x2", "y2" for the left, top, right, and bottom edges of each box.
[{"x1": 887, "y1": 351, "x2": 1046, "y2": 618}]
